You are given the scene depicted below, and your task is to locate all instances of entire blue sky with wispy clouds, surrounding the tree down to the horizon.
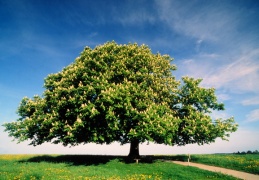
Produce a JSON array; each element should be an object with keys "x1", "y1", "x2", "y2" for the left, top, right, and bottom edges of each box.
[{"x1": 0, "y1": 0, "x2": 259, "y2": 154}]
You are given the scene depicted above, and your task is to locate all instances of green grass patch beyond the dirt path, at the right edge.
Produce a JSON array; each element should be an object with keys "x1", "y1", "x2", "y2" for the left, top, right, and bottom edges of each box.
[{"x1": 167, "y1": 154, "x2": 259, "y2": 174}]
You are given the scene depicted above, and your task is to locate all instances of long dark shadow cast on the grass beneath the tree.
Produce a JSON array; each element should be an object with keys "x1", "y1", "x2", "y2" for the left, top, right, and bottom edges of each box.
[{"x1": 19, "y1": 155, "x2": 187, "y2": 166}]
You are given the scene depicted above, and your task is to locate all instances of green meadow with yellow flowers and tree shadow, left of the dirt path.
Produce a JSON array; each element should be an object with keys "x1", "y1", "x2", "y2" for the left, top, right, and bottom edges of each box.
[{"x1": 0, "y1": 155, "x2": 241, "y2": 180}]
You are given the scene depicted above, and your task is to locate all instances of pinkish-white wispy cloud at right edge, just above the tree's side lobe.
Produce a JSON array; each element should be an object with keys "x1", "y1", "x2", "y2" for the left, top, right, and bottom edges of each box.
[{"x1": 179, "y1": 49, "x2": 259, "y2": 93}]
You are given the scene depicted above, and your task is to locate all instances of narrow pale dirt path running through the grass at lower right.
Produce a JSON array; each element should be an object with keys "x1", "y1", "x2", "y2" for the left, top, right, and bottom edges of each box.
[{"x1": 173, "y1": 161, "x2": 259, "y2": 180}]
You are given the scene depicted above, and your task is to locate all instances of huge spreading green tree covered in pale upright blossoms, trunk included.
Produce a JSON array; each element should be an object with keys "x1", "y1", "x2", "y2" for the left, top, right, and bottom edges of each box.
[{"x1": 4, "y1": 42, "x2": 237, "y2": 157}]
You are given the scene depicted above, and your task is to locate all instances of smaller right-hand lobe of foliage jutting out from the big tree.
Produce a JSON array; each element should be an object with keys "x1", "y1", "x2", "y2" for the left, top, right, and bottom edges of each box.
[{"x1": 172, "y1": 77, "x2": 237, "y2": 145}]
